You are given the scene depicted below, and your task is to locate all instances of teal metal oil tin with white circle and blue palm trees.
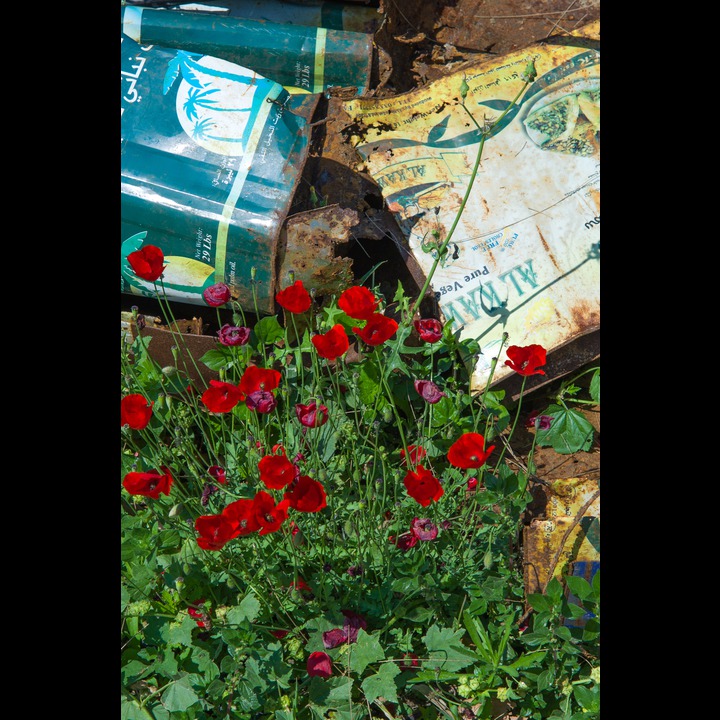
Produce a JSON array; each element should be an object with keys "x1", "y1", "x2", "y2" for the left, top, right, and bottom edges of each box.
[{"x1": 120, "y1": 34, "x2": 317, "y2": 313}]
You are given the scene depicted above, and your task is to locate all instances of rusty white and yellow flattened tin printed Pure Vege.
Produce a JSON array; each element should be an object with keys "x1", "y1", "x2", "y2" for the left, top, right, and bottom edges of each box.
[{"x1": 343, "y1": 22, "x2": 600, "y2": 391}]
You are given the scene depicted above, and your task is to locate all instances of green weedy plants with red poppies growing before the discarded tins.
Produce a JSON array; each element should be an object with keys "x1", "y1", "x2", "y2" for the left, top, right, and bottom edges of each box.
[{"x1": 121, "y1": 64, "x2": 600, "y2": 720}]
